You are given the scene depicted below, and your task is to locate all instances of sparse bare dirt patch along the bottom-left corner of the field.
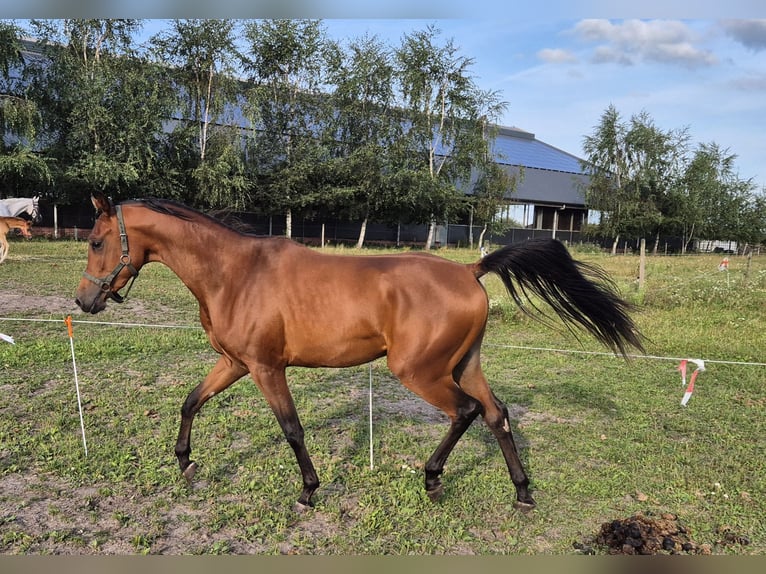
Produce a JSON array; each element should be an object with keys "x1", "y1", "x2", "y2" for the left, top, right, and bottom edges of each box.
[{"x1": 0, "y1": 474, "x2": 346, "y2": 555}]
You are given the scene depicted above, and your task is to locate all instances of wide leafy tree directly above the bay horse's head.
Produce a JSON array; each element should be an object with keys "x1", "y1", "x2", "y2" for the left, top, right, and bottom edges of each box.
[{"x1": 28, "y1": 19, "x2": 173, "y2": 202}]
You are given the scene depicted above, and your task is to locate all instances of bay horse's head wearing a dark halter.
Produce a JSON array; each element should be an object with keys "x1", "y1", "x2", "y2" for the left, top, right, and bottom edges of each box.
[{"x1": 75, "y1": 195, "x2": 143, "y2": 314}]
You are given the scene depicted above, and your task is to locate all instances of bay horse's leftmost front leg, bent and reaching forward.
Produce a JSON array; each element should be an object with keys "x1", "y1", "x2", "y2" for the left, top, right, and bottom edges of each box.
[{"x1": 175, "y1": 357, "x2": 247, "y2": 480}]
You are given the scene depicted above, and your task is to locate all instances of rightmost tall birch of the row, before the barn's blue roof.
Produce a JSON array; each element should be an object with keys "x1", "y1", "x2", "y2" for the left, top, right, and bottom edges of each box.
[{"x1": 394, "y1": 26, "x2": 506, "y2": 249}]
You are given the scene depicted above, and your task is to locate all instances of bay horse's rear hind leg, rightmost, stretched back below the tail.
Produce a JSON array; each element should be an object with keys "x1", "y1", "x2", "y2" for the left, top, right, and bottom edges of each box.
[{"x1": 456, "y1": 349, "x2": 535, "y2": 511}]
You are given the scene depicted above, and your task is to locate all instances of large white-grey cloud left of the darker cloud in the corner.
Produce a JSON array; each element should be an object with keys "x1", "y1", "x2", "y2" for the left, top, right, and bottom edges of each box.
[{"x1": 572, "y1": 20, "x2": 718, "y2": 67}]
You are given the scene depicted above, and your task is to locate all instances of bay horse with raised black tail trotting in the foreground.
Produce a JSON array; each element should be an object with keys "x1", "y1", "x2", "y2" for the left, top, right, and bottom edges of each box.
[{"x1": 76, "y1": 196, "x2": 641, "y2": 510}]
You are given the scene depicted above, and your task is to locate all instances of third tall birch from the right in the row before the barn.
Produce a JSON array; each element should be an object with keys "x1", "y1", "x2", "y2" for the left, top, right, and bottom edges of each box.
[{"x1": 244, "y1": 20, "x2": 335, "y2": 237}]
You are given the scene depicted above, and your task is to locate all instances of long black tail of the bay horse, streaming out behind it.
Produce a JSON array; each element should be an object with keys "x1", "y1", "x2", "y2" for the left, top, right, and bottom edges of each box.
[{"x1": 477, "y1": 239, "x2": 644, "y2": 356}]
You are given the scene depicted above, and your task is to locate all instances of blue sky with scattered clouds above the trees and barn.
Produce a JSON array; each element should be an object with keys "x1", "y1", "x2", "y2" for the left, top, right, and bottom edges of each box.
[{"x1": 138, "y1": 15, "x2": 766, "y2": 188}]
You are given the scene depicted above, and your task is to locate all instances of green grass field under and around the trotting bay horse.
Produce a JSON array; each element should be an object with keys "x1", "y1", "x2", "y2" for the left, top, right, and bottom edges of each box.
[{"x1": 0, "y1": 236, "x2": 766, "y2": 555}]
